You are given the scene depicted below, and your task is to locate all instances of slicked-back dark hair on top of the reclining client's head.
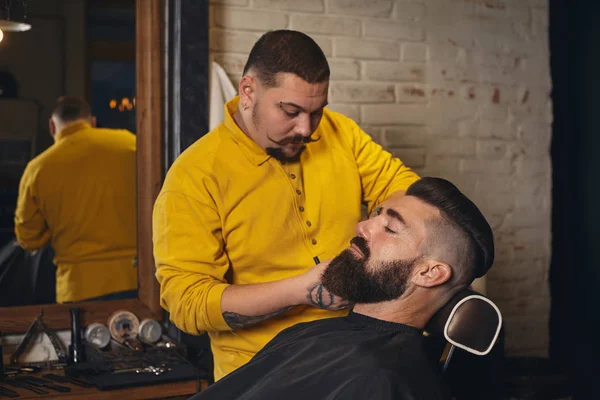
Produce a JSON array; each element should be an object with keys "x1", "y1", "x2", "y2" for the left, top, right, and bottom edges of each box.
[{"x1": 406, "y1": 177, "x2": 494, "y2": 278}]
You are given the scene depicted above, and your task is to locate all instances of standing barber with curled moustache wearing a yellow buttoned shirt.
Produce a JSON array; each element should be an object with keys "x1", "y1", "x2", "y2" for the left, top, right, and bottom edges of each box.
[{"x1": 153, "y1": 31, "x2": 418, "y2": 379}]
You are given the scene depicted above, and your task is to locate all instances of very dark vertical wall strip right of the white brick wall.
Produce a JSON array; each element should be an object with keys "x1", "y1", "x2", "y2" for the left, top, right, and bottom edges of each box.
[{"x1": 550, "y1": 0, "x2": 600, "y2": 399}]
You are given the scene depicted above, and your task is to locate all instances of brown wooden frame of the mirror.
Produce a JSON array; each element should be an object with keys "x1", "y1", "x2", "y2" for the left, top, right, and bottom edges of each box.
[{"x1": 0, "y1": 0, "x2": 165, "y2": 333}]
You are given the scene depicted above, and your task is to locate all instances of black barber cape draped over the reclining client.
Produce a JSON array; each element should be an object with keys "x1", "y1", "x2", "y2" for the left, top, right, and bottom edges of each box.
[{"x1": 192, "y1": 312, "x2": 446, "y2": 400}]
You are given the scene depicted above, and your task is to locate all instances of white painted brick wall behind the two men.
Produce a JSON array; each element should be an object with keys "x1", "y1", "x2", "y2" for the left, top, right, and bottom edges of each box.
[{"x1": 210, "y1": 0, "x2": 552, "y2": 356}]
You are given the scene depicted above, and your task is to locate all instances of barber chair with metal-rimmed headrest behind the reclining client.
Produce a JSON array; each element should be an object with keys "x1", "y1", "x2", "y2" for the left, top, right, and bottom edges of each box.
[{"x1": 425, "y1": 289, "x2": 504, "y2": 400}]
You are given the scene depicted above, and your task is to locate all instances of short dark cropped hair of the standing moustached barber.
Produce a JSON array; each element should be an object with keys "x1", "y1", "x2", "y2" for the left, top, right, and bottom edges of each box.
[{"x1": 243, "y1": 30, "x2": 330, "y2": 87}]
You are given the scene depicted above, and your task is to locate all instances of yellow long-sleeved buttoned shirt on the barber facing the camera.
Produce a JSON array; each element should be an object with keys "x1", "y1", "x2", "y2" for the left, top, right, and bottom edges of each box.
[{"x1": 153, "y1": 97, "x2": 418, "y2": 379}]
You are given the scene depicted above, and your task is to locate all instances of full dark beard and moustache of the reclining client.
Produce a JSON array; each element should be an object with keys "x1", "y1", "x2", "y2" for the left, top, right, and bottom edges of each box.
[{"x1": 322, "y1": 237, "x2": 416, "y2": 304}]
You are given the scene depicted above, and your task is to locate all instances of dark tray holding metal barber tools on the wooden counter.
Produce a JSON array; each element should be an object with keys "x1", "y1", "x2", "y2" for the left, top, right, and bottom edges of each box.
[{"x1": 65, "y1": 345, "x2": 199, "y2": 390}]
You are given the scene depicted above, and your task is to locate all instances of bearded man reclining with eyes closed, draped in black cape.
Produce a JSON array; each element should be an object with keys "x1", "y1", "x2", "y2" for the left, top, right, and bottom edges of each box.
[{"x1": 194, "y1": 178, "x2": 495, "y2": 400}]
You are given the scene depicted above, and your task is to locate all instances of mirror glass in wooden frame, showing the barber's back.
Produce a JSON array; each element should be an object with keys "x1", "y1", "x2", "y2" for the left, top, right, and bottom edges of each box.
[{"x1": 0, "y1": 0, "x2": 137, "y2": 306}]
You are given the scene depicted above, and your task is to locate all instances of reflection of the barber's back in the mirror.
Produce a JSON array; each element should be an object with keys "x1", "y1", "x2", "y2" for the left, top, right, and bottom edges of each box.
[{"x1": 15, "y1": 97, "x2": 137, "y2": 303}]
